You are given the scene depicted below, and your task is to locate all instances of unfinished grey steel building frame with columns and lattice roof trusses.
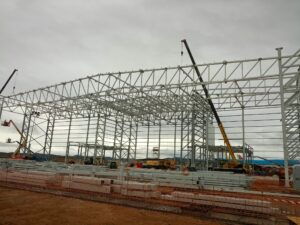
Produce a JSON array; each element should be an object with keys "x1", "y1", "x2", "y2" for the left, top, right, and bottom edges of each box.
[{"x1": 1, "y1": 49, "x2": 300, "y2": 175}]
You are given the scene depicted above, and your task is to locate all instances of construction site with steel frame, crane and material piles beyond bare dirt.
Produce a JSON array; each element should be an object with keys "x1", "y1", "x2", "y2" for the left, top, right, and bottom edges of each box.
[{"x1": 0, "y1": 40, "x2": 300, "y2": 225}]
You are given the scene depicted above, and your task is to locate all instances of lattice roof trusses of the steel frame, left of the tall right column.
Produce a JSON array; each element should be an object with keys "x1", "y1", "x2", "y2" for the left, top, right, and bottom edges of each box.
[{"x1": 3, "y1": 53, "x2": 299, "y2": 117}]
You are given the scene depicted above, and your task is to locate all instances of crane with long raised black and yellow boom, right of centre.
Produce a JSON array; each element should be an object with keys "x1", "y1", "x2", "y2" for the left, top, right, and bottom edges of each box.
[{"x1": 181, "y1": 39, "x2": 239, "y2": 168}]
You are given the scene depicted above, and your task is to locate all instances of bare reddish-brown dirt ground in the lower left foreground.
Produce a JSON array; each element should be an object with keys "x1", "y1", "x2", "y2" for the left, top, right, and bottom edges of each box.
[{"x1": 0, "y1": 187, "x2": 222, "y2": 225}]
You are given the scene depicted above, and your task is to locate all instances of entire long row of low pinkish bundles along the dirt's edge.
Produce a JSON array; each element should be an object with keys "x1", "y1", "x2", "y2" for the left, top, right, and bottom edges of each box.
[{"x1": 0, "y1": 167, "x2": 270, "y2": 213}]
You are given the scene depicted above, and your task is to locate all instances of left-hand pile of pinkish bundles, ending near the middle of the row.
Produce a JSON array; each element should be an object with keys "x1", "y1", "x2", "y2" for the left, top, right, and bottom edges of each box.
[{"x1": 0, "y1": 161, "x2": 160, "y2": 198}]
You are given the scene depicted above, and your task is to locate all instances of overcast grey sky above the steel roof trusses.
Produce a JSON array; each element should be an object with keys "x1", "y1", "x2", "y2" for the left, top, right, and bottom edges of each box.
[{"x1": 0, "y1": 0, "x2": 300, "y2": 94}]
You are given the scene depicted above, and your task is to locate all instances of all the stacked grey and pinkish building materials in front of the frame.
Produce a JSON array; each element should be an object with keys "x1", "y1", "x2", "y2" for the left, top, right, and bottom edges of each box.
[{"x1": 0, "y1": 160, "x2": 300, "y2": 225}]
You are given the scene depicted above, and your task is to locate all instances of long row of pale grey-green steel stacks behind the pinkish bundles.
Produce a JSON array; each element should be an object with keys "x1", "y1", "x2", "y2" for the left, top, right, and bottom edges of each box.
[{"x1": 0, "y1": 160, "x2": 252, "y2": 191}]
